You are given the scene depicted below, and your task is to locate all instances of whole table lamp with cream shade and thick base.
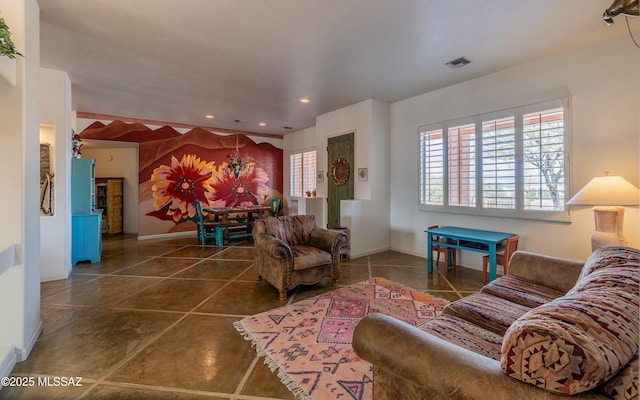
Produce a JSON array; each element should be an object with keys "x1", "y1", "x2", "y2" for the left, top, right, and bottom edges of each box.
[{"x1": 567, "y1": 172, "x2": 640, "y2": 251}]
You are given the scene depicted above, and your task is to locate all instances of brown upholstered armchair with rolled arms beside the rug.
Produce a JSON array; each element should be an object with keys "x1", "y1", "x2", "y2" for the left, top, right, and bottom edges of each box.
[{"x1": 253, "y1": 215, "x2": 349, "y2": 300}]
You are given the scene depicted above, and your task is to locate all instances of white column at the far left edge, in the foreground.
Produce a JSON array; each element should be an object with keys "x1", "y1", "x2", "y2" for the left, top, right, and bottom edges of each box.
[{"x1": 0, "y1": 0, "x2": 41, "y2": 382}]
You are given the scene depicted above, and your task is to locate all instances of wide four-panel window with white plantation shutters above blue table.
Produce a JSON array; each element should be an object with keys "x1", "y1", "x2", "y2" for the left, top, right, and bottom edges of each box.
[{"x1": 419, "y1": 98, "x2": 569, "y2": 221}]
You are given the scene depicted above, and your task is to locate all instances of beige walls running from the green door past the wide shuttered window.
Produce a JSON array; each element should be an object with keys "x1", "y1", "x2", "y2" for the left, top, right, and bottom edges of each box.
[{"x1": 284, "y1": 36, "x2": 640, "y2": 268}]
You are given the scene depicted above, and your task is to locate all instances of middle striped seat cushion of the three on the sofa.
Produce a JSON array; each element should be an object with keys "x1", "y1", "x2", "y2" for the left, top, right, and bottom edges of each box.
[{"x1": 442, "y1": 293, "x2": 530, "y2": 336}]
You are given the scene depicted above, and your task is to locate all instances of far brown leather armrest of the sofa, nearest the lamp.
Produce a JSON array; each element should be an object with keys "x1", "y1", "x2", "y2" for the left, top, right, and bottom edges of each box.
[{"x1": 509, "y1": 250, "x2": 584, "y2": 293}]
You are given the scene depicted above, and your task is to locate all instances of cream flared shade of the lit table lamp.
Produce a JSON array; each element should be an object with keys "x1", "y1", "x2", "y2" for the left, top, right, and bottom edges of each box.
[{"x1": 567, "y1": 176, "x2": 640, "y2": 206}]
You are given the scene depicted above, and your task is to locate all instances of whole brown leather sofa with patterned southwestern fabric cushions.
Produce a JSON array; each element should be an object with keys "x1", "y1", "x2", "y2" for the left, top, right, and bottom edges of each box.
[{"x1": 353, "y1": 247, "x2": 640, "y2": 400}]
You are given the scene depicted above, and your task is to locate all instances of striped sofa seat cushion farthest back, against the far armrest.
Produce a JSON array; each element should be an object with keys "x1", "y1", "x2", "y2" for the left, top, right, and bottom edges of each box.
[{"x1": 480, "y1": 275, "x2": 564, "y2": 308}]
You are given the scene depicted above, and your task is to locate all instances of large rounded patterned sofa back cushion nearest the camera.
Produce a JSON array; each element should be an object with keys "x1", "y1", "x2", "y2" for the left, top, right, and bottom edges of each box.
[{"x1": 501, "y1": 288, "x2": 640, "y2": 395}]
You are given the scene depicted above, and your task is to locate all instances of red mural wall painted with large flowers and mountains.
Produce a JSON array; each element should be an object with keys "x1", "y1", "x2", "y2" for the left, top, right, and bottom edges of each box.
[{"x1": 79, "y1": 121, "x2": 283, "y2": 236}]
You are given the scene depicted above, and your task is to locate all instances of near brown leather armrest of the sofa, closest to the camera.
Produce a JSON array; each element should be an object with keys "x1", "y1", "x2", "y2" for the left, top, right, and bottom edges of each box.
[{"x1": 353, "y1": 314, "x2": 602, "y2": 400}]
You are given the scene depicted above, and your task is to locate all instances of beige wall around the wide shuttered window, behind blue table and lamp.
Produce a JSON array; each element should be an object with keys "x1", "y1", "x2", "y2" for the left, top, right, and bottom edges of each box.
[{"x1": 390, "y1": 36, "x2": 640, "y2": 267}]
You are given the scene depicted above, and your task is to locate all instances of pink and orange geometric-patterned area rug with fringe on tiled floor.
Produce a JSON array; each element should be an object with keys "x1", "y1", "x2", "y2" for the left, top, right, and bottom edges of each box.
[{"x1": 234, "y1": 278, "x2": 447, "y2": 400}]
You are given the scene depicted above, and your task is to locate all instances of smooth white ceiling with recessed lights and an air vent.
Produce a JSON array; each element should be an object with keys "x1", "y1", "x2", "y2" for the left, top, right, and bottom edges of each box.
[{"x1": 39, "y1": 0, "x2": 640, "y2": 134}]
